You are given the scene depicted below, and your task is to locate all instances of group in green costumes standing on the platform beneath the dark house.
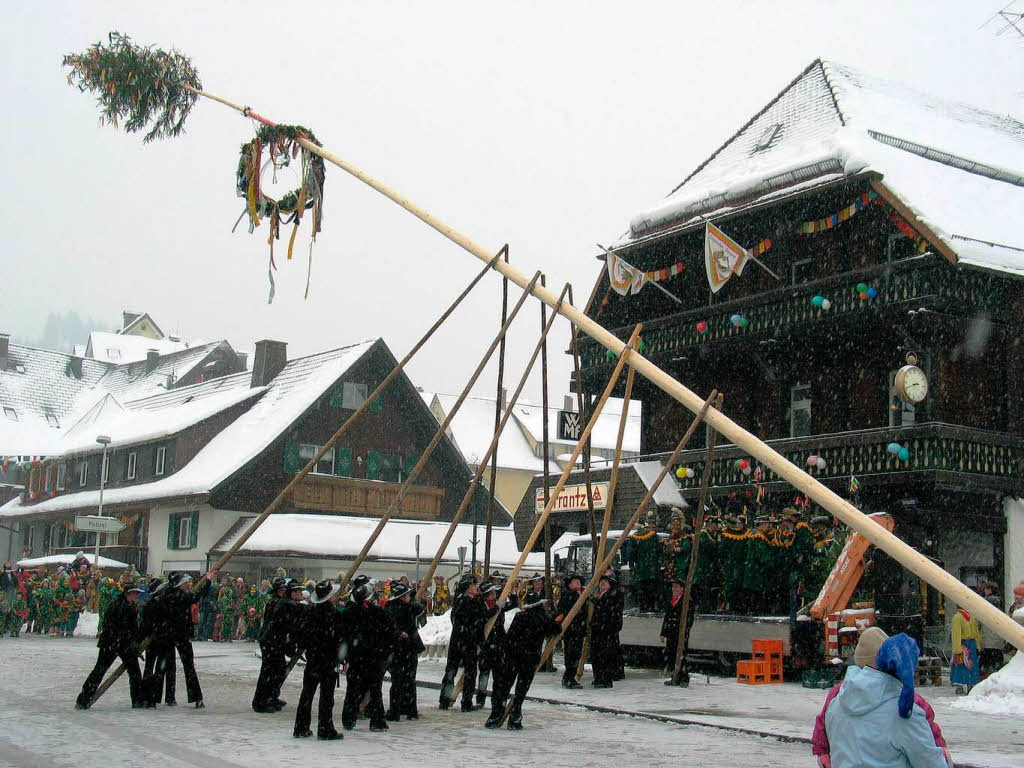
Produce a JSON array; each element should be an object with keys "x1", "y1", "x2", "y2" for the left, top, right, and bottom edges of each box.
[{"x1": 623, "y1": 507, "x2": 835, "y2": 622}]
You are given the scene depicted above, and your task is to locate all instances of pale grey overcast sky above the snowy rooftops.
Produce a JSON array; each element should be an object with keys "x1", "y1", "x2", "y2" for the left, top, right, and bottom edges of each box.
[{"x1": 0, "y1": 0, "x2": 1024, "y2": 402}]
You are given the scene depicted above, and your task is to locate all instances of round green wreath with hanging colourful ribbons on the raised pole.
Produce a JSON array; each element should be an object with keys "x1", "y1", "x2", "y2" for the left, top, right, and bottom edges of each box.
[{"x1": 236, "y1": 125, "x2": 326, "y2": 301}]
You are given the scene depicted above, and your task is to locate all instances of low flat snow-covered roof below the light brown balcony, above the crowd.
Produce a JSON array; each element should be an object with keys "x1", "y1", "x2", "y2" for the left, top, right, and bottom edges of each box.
[{"x1": 211, "y1": 514, "x2": 572, "y2": 569}]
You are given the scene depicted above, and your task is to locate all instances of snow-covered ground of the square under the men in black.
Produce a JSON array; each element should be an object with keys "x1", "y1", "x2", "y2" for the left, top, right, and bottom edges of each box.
[{"x1": 0, "y1": 636, "x2": 1024, "y2": 768}]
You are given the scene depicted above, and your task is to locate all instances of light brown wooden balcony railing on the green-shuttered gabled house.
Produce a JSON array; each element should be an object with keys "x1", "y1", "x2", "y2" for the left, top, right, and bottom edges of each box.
[{"x1": 292, "y1": 475, "x2": 444, "y2": 520}]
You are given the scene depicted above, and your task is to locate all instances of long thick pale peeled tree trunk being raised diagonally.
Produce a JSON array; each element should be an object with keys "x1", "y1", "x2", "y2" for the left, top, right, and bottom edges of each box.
[{"x1": 182, "y1": 85, "x2": 1024, "y2": 650}]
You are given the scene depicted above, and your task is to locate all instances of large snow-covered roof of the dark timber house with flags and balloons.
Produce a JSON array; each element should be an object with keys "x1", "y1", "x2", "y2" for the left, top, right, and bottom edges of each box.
[{"x1": 618, "y1": 59, "x2": 1024, "y2": 274}]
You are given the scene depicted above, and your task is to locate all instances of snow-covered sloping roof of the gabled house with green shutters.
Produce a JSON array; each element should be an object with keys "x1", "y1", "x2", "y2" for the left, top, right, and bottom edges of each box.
[{"x1": 0, "y1": 339, "x2": 378, "y2": 517}]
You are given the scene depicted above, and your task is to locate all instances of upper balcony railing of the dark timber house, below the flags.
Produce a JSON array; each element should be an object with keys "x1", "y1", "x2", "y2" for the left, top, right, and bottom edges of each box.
[{"x1": 580, "y1": 254, "x2": 1020, "y2": 370}]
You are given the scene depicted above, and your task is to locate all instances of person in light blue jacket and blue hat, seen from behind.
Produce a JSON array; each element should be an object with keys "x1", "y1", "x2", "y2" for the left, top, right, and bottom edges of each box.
[{"x1": 825, "y1": 634, "x2": 946, "y2": 768}]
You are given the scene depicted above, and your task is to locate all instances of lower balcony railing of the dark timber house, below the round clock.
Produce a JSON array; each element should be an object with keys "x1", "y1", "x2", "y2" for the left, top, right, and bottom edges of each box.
[{"x1": 634, "y1": 423, "x2": 1024, "y2": 497}]
